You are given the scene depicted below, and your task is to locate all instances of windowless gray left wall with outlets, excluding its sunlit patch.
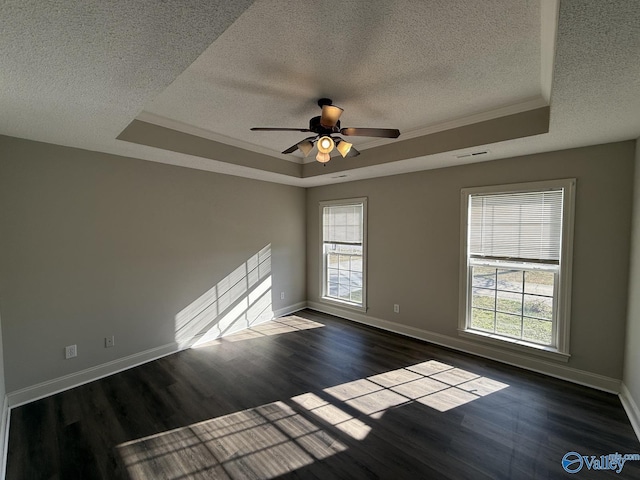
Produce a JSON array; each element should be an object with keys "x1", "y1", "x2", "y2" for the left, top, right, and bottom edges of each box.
[{"x1": 0, "y1": 137, "x2": 306, "y2": 392}]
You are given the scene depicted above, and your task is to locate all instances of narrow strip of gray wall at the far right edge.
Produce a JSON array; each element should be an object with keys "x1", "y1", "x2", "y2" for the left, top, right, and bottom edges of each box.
[{"x1": 623, "y1": 139, "x2": 640, "y2": 408}]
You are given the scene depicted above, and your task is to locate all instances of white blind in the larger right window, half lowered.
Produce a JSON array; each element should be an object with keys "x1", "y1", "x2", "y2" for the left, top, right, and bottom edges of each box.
[{"x1": 469, "y1": 189, "x2": 564, "y2": 264}]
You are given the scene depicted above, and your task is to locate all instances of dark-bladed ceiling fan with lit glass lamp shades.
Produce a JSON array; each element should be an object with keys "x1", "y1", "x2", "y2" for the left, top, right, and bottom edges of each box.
[{"x1": 251, "y1": 98, "x2": 400, "y2": 164}]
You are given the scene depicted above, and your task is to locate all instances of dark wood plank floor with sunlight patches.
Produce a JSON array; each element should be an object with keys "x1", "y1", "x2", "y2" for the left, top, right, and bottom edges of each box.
[{"x1": 7, "y1": 311, "x2": 640, "y2": 480}]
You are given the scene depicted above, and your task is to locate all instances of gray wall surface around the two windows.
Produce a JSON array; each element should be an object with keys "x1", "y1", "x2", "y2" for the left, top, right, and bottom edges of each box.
[{"x1": 307, "y1": 142, "x2": 635, "y2": 379}]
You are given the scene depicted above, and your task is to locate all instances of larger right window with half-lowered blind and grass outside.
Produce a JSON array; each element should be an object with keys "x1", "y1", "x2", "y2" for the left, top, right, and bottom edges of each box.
[{"x1": 460, "y1": 179, "x2": 575, "y2": 358}]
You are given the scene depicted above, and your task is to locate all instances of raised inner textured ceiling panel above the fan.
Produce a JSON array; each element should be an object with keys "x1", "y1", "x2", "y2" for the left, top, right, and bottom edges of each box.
[{"x1": 139, "y1": 0, "x2": 541, "y2": 158}]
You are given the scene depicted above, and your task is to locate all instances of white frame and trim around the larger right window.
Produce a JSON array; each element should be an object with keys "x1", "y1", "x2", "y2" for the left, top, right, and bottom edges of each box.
[{"x1": 458, "y1": 178, "x2": 576, "y2": 362}]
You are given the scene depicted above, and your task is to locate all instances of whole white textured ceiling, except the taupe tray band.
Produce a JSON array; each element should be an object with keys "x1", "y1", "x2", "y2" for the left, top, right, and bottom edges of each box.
[{"x1": 0, "y1": 0, "x2": 640, "y2": 186}]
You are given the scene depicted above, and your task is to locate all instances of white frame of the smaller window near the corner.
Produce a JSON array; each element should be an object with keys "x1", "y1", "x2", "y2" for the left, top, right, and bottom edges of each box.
[{"x1": 319, "y1": 197, "x2": 367, "y2": 312}]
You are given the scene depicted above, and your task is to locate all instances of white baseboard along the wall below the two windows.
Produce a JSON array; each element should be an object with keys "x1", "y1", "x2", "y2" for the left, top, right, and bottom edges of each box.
[{"x1": 307, "y1": 302, "x2": 621, "y2": 393}]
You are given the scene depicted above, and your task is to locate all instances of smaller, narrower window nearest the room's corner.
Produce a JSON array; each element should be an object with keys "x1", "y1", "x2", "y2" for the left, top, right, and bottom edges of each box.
[{"x1": 320, "y1": 198, "x2": 367, "y2": 309}]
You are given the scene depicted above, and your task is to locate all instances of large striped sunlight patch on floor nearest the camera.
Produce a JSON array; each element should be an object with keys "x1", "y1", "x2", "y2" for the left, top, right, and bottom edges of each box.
[{"x1": 118, "y1": 402, "x2": 347, "y2": 480}]
